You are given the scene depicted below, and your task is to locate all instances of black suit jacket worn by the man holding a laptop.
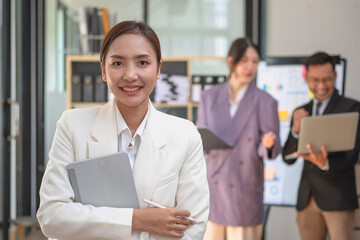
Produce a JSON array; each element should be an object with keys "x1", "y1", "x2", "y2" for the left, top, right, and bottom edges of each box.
[{"x1": 283, "y1": 90, "x2": 360, "y2": 211}]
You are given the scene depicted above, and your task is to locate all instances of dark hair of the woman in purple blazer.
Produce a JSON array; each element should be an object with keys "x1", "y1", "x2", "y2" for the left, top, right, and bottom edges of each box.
[{"x1": 228, "y1": 38, "x2": 260, "y2": 67}]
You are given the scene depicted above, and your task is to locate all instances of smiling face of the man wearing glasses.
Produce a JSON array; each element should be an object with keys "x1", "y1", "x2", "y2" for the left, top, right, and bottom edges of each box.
[{"x1": 305, "y1": 63, "x2": 336, "y2": 101}]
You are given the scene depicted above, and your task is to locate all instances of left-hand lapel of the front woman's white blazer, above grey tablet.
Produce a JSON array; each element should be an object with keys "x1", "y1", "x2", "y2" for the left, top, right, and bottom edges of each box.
[{"x1": 88, "y1": 99, "x2": 118, "y2": 157}]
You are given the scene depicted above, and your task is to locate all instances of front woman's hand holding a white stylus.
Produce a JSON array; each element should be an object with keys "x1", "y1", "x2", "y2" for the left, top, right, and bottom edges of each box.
[{"x1": 132, "y1": 207, "x2": 194, "y2": 238}]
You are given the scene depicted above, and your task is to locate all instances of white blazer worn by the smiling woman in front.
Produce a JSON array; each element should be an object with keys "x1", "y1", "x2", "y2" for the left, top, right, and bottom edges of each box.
[{"x1": 37, "y1": 100, "x2": 209, "y2": 240}]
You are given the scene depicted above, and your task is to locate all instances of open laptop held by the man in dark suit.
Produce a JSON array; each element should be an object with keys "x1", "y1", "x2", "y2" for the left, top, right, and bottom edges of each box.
[{"x1": 285, "y1": 112, "x2": 359, "y2": 159}]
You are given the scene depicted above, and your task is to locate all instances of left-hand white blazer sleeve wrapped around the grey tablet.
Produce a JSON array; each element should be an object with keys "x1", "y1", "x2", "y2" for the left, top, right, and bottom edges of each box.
[{"x1": 37, "y1": 114, "x2": 133, "y2": 240}]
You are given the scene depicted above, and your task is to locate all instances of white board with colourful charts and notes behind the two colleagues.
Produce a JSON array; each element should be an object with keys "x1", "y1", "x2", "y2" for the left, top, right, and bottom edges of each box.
[{"x1": 256, "y1": 56, "x2": 346, "y2": 206}]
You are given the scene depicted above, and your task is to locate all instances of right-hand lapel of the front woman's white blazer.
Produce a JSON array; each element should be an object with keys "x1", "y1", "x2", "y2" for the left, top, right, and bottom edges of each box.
[{"x1": 133, "y1": 105, "x2": 168, "y2": 208}]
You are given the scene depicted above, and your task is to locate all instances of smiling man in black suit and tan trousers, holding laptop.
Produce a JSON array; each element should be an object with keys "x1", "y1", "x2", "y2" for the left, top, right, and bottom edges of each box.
[{"x1": 283, "y1": 52, "x2": 360, "y2": 240}]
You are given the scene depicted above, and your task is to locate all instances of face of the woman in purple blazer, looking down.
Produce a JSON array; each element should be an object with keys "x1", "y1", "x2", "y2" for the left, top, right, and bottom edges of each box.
[{"x1": 231, "y1": 47, "x2": 259, "y2": 85}]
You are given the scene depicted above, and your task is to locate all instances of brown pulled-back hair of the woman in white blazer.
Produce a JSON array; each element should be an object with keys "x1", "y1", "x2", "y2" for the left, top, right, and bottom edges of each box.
[{"x1": 100, "y1": 21, "x2": 161, "y2": 65}]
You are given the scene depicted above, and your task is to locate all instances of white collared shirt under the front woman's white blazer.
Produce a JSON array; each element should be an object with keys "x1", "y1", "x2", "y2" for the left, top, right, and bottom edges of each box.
[{"x1": 116, "y1": 104, "x2": 150, "y2": 170}]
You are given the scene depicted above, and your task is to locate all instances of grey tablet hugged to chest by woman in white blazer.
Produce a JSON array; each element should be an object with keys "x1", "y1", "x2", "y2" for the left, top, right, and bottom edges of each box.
[{"x1": 67, "y1": 153, "x2": 140, "y2": 208}]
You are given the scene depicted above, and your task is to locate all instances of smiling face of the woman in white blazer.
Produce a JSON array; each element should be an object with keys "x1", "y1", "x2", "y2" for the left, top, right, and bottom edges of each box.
[{"x1": 101, "y1": 34, "x2": 161, "y2": 110}]
